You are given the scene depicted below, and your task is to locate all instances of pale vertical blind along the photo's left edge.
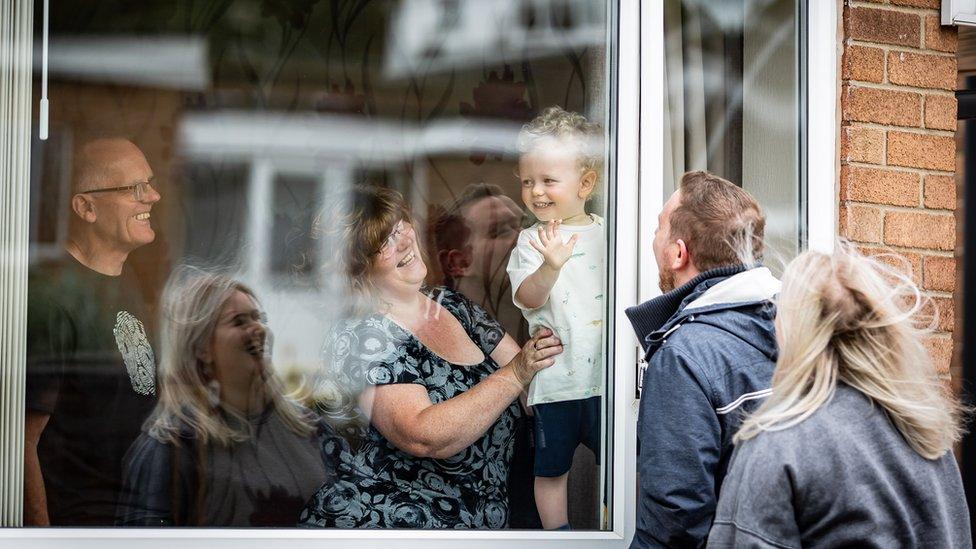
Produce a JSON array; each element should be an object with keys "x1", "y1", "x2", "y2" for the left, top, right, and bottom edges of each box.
[{"x1": 0, "y1": 0, "x2": 33, "y2": 527}]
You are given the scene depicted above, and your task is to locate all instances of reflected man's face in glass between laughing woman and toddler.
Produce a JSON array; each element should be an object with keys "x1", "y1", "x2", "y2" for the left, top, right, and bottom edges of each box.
[{"x1": 461, "y1": 196, "x2": 522, "y2": 280}]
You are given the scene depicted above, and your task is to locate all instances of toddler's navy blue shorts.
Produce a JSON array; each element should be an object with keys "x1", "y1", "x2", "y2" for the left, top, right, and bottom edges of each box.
[{"x1": 532, "y1": 396, "x2": 601, "y2": 477}]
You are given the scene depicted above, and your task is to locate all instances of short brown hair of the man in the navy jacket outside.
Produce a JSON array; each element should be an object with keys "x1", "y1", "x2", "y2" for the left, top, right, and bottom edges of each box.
[{"x1": 671, "y1": 171, "x2": 766, "y2": 272}]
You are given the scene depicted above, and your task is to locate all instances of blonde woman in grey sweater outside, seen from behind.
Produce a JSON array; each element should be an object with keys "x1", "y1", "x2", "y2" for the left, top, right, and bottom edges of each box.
[{"x1": 708, "y1": 244, "x2": 972, "y2": 548}]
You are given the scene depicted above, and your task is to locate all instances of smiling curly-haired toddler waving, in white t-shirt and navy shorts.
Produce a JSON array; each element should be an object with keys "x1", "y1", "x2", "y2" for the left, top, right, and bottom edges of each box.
[{"x1": 508, "y1": 107, "x2": 606, "y2": 529}]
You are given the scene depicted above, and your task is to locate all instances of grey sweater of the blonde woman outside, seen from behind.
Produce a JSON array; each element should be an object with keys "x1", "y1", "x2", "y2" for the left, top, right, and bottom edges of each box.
[{"x1": 708, "y1": 384, "x2": 972, "y2": 548}]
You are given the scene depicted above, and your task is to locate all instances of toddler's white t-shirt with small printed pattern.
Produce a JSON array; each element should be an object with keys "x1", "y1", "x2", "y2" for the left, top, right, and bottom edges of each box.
[{"x1": 508, "y1": 214, "x2": 607, "y2": 406}]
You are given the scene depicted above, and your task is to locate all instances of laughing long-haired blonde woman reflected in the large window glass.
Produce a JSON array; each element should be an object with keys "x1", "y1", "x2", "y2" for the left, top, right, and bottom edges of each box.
[{"x1": 117, "y1": 269, "x2": 331, "y2": 526}]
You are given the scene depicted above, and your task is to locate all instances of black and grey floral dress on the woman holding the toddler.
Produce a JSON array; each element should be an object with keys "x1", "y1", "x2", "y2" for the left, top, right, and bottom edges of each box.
[{"x1": 299, "y1": 288, "x2": 520, "y2": 528}]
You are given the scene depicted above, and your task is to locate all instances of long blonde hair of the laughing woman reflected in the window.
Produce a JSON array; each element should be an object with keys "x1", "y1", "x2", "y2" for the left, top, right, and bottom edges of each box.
[{"x1": 146, "y1": 266, "x2": 313, "y2": 445}]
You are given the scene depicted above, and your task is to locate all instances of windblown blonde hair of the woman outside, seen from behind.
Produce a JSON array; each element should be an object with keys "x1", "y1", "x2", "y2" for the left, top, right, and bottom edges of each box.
[{"x1": 734, "y1": 242, "x2": 964, "y2": 459}]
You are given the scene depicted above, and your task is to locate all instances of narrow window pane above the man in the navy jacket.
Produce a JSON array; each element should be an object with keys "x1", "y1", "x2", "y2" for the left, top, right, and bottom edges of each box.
[{"x1": 664, "y1": 0, "x2": 803, "y2": 260}]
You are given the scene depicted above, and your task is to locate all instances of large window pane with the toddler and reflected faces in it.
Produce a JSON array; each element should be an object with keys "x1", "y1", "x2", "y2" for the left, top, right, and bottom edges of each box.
[{"x1": 25, "y1": 0, "x2": 614, "y2": 530}]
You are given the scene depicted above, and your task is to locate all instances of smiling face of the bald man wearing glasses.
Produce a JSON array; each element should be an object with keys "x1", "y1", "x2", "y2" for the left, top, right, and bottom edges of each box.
[{"x1": 87, "y1": 141, "x2": 161, "y2": 250}]
